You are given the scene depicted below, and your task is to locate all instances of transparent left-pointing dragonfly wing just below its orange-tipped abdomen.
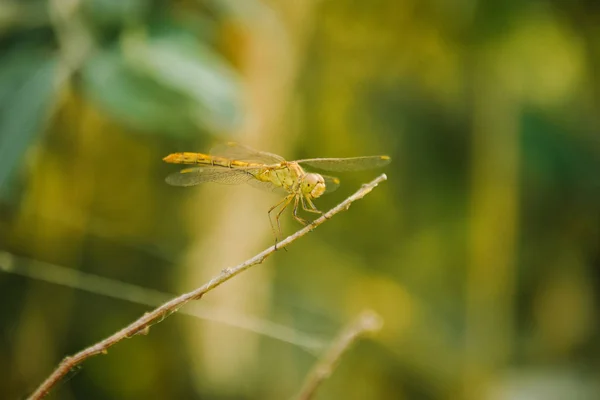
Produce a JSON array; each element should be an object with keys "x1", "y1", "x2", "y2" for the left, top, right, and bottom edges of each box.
[{"x1": 165, "y1": 167, "x2": 254, "y2": 186}]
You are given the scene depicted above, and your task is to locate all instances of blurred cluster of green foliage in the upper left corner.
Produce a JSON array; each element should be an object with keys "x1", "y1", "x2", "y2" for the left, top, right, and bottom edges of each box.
[{"x1": 0, "y1": 0, "x2": 241, "y2": 198}]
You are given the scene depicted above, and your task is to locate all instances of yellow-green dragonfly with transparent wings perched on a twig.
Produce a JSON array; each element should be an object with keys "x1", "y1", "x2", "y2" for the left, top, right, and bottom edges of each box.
[{"x1": 163, "y1": 142, "x2": 391, "y2": 238}]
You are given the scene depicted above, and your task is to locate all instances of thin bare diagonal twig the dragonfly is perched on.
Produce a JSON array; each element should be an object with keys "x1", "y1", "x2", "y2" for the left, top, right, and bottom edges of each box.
[{"x1": 29, "y1": 174, "x2": 387, "y2": 399}]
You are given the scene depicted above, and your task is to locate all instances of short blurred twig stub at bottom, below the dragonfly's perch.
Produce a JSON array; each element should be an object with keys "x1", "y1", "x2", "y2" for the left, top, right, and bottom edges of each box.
[{"x1": 296, "y1": 311, "x2": 383, "y2": 400}]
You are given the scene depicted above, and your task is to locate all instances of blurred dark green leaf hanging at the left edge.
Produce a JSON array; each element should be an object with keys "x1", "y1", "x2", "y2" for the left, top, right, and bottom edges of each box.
[{"x1": 0, "y1": 48, "x2": 57, "y2": 197}]
